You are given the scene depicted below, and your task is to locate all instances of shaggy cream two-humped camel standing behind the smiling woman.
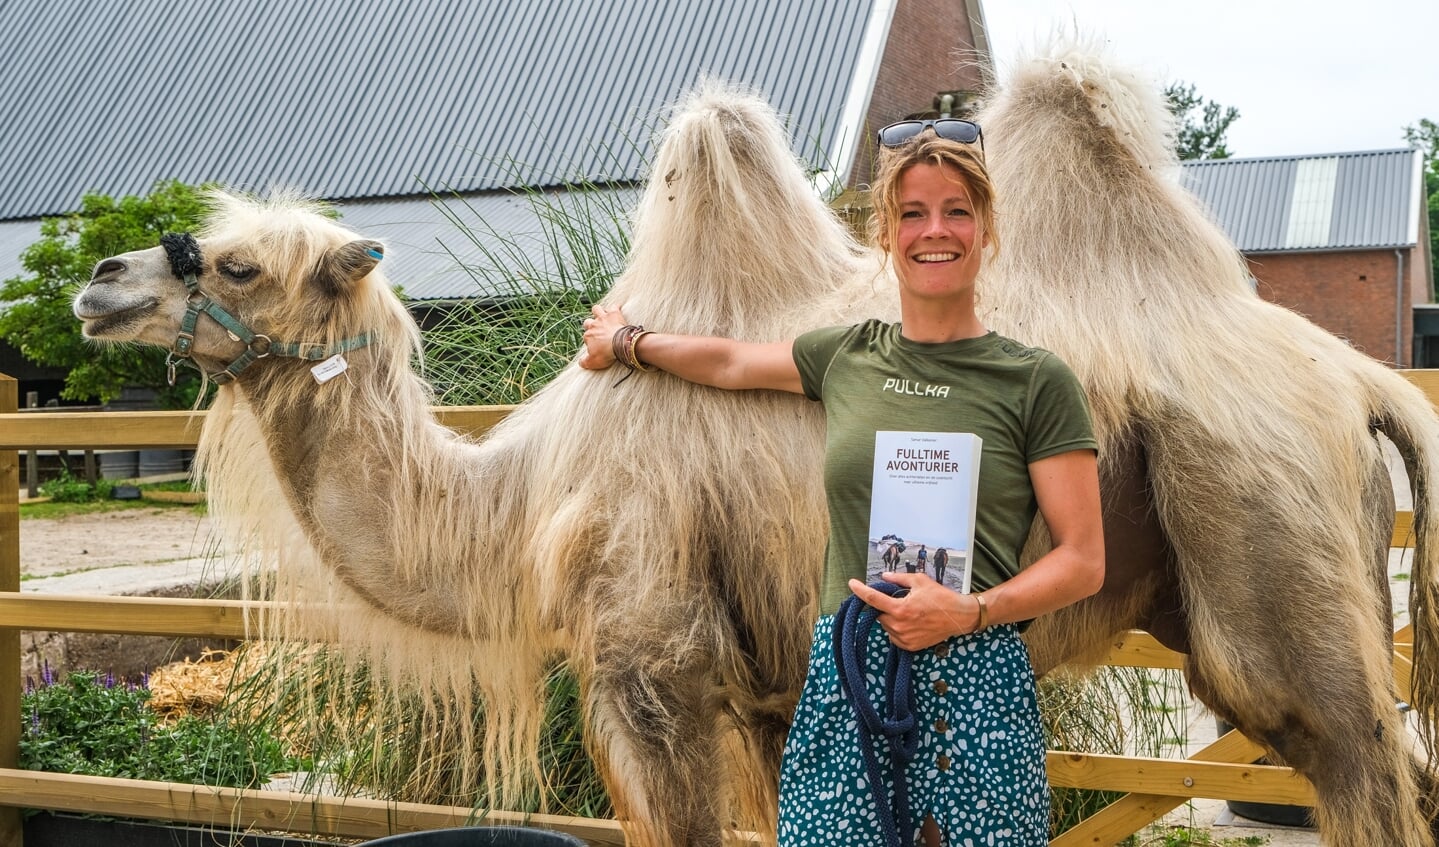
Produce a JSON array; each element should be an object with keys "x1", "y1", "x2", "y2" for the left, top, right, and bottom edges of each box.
[{"x1": 75, "y1": 50, "x2": 1439, "y2": 847}]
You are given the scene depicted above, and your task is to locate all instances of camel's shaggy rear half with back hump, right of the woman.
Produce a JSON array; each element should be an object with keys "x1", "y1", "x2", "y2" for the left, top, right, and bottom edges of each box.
[{"x1": 979, "y1": 49, "x2": 1439, "y2": 847}]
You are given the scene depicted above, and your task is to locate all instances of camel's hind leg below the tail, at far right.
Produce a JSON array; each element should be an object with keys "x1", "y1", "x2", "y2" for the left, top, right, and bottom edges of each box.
[{"x1": 1184, "y1": 463, "x2": 1435, "y2": 847}]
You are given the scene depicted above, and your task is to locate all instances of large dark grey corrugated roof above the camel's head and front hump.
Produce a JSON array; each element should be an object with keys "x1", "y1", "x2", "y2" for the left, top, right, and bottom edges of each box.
[{"x1": 0, "y1": 0, "x2": 892, "y2": 220}]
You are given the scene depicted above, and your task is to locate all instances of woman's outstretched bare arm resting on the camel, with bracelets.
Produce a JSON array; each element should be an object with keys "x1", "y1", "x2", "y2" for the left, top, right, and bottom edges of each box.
[{"x1": 580, "y1": 306, "x2": 804, "y2": 394}]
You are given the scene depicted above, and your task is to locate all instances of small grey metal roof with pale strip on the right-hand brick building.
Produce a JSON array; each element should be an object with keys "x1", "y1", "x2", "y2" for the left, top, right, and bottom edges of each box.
[{"x1": 1183, "y1": 150, "x2": 1423, "y2": 253}]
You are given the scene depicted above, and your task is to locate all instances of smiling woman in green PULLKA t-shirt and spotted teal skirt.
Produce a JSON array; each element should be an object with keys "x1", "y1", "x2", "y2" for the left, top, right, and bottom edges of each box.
[{"x1": 580, "y1": 119, "x2": 1104, "y2": 847}]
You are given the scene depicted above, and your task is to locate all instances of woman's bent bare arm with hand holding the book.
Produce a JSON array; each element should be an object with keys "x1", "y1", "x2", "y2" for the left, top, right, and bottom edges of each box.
[{"x1": 849, "y1": 450, "x2": 1104, "y2": 650}]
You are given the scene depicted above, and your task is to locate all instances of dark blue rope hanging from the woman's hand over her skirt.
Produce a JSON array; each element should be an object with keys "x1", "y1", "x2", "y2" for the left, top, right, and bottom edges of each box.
[{"x1": 833, "y1": 581, "x2": 920, "y2": 847}]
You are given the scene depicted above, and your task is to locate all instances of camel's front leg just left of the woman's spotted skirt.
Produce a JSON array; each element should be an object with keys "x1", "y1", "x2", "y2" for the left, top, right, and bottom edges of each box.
[{"x1": 587, "y1": 644, "x2": 727, "y2": 847}]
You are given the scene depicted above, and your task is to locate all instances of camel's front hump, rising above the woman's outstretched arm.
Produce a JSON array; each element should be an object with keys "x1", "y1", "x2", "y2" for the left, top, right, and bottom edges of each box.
[{"x1": 606, "y1": 79, "x2": 863, "y2": 341}]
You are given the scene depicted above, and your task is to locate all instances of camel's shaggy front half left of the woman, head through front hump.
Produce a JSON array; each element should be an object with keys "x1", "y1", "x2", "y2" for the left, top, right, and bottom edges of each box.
[{"x1": 75, "y1": 82, "x2": 895, "y2": 847}]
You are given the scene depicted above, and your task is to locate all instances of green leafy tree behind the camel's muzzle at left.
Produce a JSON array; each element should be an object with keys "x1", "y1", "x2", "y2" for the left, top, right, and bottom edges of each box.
[{"x1": 0, "y1": 180, "x2": 204, "y2": 407}]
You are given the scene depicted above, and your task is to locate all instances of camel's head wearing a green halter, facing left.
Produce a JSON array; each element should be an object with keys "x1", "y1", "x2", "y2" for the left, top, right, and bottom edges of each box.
[{"x1": 73, "y1": 191, "x2": 413, "y2": 383}]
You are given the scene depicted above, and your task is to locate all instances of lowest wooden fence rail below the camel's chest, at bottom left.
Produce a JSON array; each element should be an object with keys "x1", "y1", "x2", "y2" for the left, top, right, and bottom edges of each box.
[{"x1": 0, "y1": 768, "x2": 625, "y2": 847}]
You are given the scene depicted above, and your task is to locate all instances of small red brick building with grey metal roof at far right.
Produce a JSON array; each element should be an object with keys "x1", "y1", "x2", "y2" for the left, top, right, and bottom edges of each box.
[{"x1": 1183, "y1": 150, "x2": 1439, "y2": 367}]
